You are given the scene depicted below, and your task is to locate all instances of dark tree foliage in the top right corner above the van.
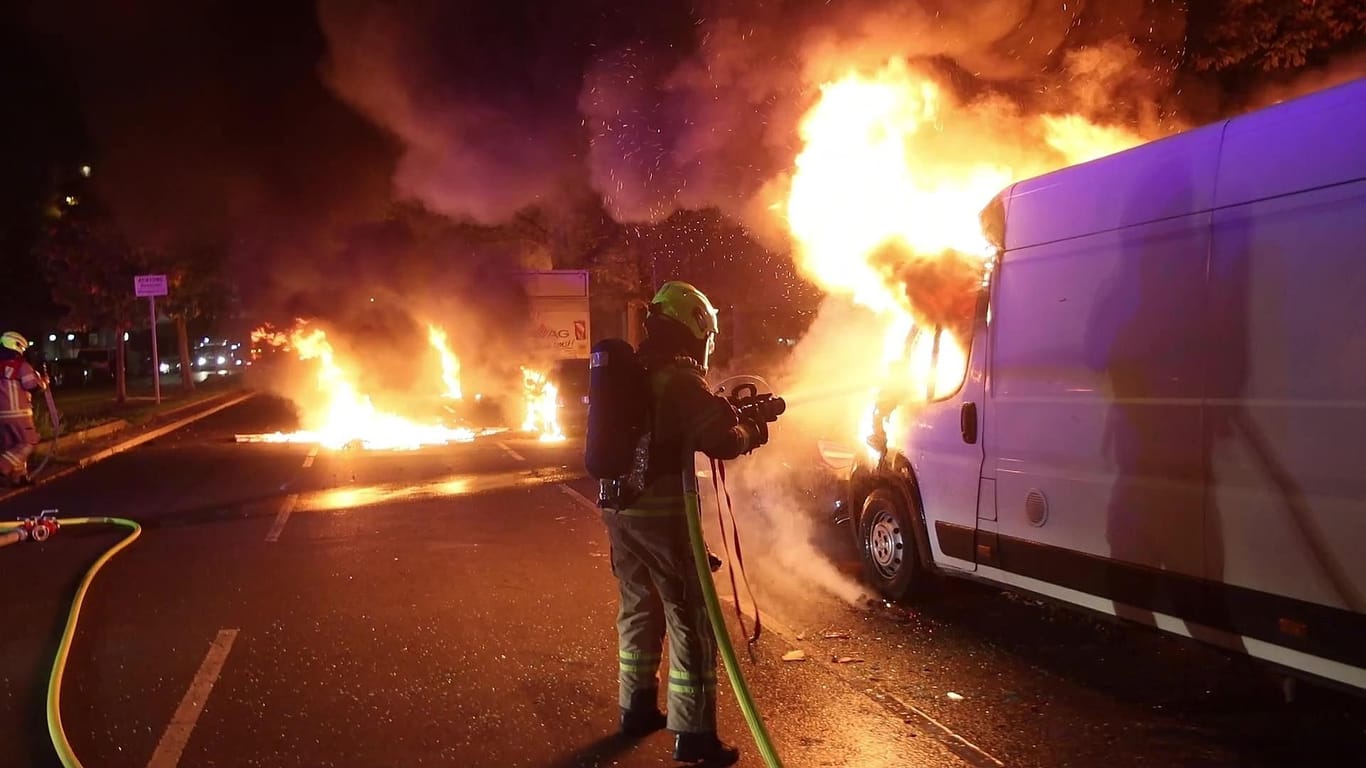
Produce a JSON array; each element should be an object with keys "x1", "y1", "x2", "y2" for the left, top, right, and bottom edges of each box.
[{"x1": 1187, "y1": 0, "x2": 1366, "y2": 72}]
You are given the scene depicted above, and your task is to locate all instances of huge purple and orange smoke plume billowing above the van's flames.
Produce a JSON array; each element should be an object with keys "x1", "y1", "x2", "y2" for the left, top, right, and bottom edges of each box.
[{"x1": 320, "y1": 0, "x2": 1184, "y2": 223}]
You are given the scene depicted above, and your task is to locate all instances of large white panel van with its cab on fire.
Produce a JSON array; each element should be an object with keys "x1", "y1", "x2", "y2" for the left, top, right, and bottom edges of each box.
[{"x1": 851, "y1": 79, "x2": 1366, "y2": 689}]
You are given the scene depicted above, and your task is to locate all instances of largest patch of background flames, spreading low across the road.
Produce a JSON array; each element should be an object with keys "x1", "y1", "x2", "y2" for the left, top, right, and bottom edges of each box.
[{"x1": 248, "y1": 323, "x2": 478, "y2": 450}]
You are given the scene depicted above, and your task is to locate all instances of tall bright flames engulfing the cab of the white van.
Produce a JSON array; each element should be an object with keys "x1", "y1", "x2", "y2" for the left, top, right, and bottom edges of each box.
[{"x1": 776, "y1": 61, "x2": 1141, "y2": 459}]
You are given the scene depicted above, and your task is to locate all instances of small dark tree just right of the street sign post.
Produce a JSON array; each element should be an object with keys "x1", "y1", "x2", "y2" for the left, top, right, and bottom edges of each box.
[{"x1": 153, "y1": 245, "x2": 236, "y2": 391}]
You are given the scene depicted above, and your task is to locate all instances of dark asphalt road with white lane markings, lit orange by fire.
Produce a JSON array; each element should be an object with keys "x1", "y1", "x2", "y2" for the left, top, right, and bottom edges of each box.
[{"x1": 0, "y1": 398, "x2": 1366, "y2": 768}]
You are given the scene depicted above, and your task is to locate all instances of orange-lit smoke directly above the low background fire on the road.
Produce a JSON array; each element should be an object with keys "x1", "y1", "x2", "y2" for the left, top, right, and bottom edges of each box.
[{"x1": 260, "y1": 206, "x2": 534, "y2": 396}]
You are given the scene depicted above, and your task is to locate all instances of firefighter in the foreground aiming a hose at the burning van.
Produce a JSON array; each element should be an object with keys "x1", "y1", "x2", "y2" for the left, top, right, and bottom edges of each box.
[{"x1": 602, "y1": 282, "x2": 768, "y2": 765}]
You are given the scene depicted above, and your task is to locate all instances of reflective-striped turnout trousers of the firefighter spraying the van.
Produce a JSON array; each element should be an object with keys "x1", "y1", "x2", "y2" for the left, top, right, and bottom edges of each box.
[{"x1": 602, "y1": 508, "x2": 716, "y2": 732}]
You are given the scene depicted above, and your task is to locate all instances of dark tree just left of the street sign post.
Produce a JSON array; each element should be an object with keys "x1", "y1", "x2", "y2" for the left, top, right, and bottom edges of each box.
[{"x1": 38, "y1": 212, "x2": 150, "y2": 403}]
